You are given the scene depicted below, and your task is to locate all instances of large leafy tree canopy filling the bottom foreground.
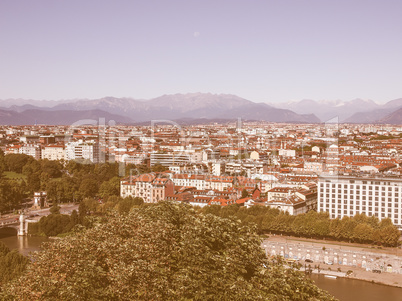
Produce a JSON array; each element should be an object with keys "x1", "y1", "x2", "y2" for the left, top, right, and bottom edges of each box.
[{"x1": 3, "y1": 202, "x2": 333, "y2": 300}]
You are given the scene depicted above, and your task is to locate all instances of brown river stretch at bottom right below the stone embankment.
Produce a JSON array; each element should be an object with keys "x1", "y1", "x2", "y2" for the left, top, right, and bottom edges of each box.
[{"x1": 310, "y1": 274, "x2": 402, "y2": 301}]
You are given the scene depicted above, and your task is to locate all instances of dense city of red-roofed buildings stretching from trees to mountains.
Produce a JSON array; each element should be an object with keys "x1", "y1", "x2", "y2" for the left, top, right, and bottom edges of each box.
[{"x1": 0, "y1": 120, "x2": 402, "y2": 225}]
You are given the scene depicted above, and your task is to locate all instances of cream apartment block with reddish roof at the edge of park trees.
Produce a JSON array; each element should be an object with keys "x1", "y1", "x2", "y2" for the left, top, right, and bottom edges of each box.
[{"x1": 120, "y1": 173, "x2": 174, "y2": 203}]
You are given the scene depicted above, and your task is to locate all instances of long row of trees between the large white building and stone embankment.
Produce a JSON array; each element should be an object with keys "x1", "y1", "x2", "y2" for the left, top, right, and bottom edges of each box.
[{"x1": 201, "y1": 205, "x2": 400, "y2": 247}]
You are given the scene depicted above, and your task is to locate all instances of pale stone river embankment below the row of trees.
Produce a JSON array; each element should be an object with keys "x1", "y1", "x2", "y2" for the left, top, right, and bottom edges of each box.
[{"x1": 263, "y1": 236, "x2": 402, "y2": 288}]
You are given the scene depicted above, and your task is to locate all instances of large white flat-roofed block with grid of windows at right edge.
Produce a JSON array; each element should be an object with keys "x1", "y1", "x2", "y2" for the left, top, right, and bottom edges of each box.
[{"x1": 317, "y1": 176, "x2": 402, "y2": 230}]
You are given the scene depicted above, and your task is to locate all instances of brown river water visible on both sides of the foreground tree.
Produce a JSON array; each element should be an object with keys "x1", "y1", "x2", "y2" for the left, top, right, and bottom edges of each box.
[{"x1": 0, "y1": 234, "x2": 402, "y2": 301}]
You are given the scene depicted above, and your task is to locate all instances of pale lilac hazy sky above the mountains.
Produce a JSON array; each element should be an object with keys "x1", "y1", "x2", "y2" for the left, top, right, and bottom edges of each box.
[{"x1": 0, "y1": 0, "x2": 402, "y2": 102}]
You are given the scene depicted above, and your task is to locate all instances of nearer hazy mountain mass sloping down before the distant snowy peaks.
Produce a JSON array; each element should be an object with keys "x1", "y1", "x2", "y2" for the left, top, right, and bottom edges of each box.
[{"x1": 0, "y1": 93, "x2": 320, "y2": 124}]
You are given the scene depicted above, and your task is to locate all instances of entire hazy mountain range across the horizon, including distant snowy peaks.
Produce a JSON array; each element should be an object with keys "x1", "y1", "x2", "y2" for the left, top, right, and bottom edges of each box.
[{"x1": 0, "y1": 93, "x2": 402, "y2": 125}]
